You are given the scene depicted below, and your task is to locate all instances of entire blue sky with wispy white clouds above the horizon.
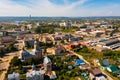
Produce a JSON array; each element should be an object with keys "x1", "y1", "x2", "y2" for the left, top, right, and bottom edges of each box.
[{"x1": 0, "y1": 0, "x2": 120, "y2": 17}]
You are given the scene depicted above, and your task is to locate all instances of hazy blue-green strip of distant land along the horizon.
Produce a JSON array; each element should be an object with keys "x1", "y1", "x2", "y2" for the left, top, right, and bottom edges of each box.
[{"x1": 0, "y1": 16, "x2": 120, "y2": 21}]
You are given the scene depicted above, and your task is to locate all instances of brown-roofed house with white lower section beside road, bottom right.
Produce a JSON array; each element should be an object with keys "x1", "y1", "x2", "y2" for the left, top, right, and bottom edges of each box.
[{"x1": 89, "y1": 68, "x2": 107, "y2": 80}]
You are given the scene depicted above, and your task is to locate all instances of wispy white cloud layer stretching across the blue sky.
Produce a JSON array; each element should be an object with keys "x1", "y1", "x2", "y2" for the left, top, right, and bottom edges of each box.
[{"x1": 0, "y1": 0, "x2": 120, "y2": 16}]
